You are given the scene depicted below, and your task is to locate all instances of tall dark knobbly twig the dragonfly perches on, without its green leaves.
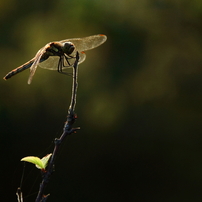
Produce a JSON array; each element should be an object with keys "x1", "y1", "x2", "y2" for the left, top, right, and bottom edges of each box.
[{"x1": 35, "y1": 52, "x2": 80, "y2": 202}]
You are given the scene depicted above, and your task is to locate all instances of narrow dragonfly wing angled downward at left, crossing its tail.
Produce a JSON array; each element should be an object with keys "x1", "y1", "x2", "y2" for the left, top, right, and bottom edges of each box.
[{"x1": 28, "y1": 46, "x2": 46, "y2": 84}]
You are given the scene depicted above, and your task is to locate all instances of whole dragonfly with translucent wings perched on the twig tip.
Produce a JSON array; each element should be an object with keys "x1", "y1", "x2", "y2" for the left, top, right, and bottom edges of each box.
[{"x1": 3, "y1": 34, "x2": 107, "y2": 84}]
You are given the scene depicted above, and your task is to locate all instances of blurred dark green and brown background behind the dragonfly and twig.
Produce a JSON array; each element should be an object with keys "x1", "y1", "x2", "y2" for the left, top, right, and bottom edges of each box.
[{"x1": 0, "y1": 0, "x2": 202, "y2": 202}]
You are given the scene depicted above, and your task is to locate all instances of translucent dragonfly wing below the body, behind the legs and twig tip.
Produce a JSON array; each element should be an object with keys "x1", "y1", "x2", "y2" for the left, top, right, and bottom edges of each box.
[{"x1": 38, "y1": 52, "x2": 86, "y2": 70}]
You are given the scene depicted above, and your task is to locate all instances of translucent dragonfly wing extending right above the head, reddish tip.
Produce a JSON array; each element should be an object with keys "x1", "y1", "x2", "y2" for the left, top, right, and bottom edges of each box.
[{"x1": 60, "y1": 34, "x2": 107, "y2": 52}]
